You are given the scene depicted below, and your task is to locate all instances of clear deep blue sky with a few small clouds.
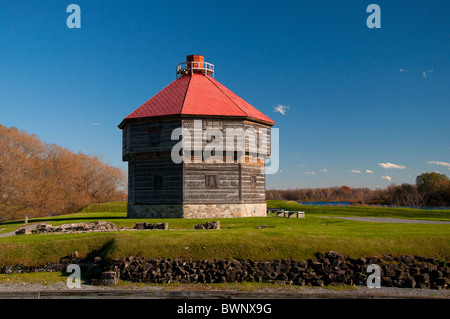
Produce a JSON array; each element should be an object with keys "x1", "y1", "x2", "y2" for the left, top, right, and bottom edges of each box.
[{"x1": 0, "y1": 0, "x2": 450, "y2": 188}]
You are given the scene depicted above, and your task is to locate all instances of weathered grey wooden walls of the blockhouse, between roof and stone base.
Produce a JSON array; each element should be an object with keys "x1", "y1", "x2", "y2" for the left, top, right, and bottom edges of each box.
[{"x1": 123, "y1": 119, "x2": 270, "y2": 205}]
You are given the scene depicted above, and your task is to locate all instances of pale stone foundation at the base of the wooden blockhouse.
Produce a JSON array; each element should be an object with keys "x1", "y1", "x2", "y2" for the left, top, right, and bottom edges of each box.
[{"x1": 127, "y1": 203, "x2": 267, "y2": 218}]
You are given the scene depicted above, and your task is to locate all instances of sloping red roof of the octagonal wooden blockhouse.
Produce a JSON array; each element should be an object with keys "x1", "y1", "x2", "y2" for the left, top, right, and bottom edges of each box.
[{"x1": 122, "y1": 73, "x2": 275, "y2": 125}]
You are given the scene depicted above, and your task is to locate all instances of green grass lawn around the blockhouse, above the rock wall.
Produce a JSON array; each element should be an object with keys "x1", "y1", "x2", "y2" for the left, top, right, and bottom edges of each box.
[{"x1": 0, "y1": 201, "x2": 450, "y2": 266}]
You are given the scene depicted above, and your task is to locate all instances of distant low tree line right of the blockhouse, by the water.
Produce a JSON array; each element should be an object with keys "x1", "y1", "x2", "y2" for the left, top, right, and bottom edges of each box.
[{"x1": 266, "y1": 172, "x2": 450, "y2": 207}]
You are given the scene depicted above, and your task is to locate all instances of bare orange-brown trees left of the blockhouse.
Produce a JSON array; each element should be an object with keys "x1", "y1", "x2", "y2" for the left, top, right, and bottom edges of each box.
[{"x1": 0, "y1": 125, "x2": 127, "y2": 221}]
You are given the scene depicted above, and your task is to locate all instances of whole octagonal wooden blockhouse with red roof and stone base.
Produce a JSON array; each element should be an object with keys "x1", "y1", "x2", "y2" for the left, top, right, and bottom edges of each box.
[{"x1": 119, "y1": 55, "x2": 275, "y2": 218}]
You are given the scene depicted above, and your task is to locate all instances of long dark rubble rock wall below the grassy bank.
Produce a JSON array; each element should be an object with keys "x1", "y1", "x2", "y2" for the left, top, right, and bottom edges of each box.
[{"x1": 103, "y1": 252, "x2": 450, "y2": 289}]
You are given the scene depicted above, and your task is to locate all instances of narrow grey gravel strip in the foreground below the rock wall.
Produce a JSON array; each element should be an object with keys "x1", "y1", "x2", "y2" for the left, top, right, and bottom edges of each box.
[{"x1": 0, "y1": 282, "x2": 450, "y2": 299}]
